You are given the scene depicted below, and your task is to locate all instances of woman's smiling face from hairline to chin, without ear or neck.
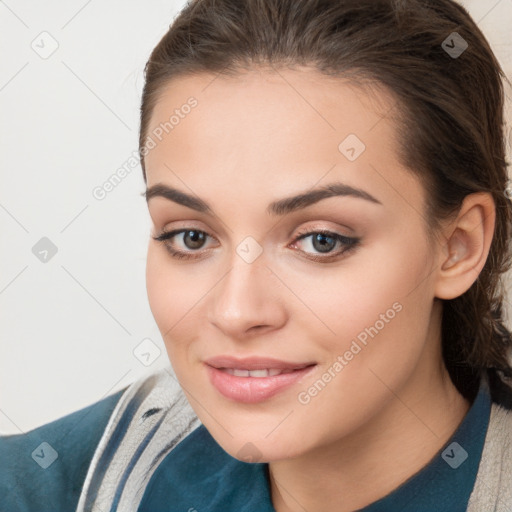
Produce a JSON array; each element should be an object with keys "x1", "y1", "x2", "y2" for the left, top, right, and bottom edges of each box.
[{"x1": 145, "y1": 69, "x2": 440, "y2": 461}]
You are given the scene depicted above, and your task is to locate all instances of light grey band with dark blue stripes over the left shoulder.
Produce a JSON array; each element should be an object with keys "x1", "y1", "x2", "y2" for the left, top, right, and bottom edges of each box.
[{"x1": 77, "y1": 367, "x2": 204, "y2": 512}]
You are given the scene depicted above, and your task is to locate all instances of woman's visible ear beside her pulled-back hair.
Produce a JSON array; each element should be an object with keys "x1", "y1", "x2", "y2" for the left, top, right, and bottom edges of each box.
[{"x1": 435, "y1": 192, "x2": 496, "y2": 299}]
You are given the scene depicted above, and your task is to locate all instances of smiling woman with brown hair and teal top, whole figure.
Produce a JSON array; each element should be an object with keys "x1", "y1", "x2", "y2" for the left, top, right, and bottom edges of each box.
[{"x1": 1, "y1": 0, "x2": 512, "y2": 512}]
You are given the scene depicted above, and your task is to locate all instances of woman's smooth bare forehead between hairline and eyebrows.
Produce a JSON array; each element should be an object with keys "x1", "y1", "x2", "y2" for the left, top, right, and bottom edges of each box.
[{"x1": 145, "y1": 68, "x2": 421, "y2": 215}]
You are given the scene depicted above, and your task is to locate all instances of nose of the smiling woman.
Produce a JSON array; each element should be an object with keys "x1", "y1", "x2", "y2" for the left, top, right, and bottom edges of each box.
[{"x1": 208, "y1": 254, "x2": 286, "y2": 340}]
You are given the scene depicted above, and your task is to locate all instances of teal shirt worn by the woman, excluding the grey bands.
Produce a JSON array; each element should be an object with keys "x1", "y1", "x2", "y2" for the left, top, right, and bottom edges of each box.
[{"x1": 0, "y1": 381, "x2": 492, "y2": 512}]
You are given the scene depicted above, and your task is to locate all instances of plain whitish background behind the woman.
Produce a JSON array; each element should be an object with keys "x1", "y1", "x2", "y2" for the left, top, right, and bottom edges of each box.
[{"x1": 0, "y1": 0, "x2": 512, "y2": 434}]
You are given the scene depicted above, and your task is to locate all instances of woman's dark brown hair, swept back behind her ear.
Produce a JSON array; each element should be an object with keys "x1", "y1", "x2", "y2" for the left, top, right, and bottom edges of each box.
[{"x1": 139, "y1": 0, "x2": 512, "y2": 407}]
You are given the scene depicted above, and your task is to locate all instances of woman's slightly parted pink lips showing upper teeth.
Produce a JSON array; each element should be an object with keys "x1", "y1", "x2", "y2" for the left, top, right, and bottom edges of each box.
[{"x1": 205, "y1": 356, "x2": 316, "y2": 403}]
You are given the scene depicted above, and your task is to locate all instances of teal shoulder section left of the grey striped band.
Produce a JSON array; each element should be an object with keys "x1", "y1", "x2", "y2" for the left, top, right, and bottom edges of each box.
[{"x1": 0, "y1": 388, "x2": 126, "y2": 512}]
